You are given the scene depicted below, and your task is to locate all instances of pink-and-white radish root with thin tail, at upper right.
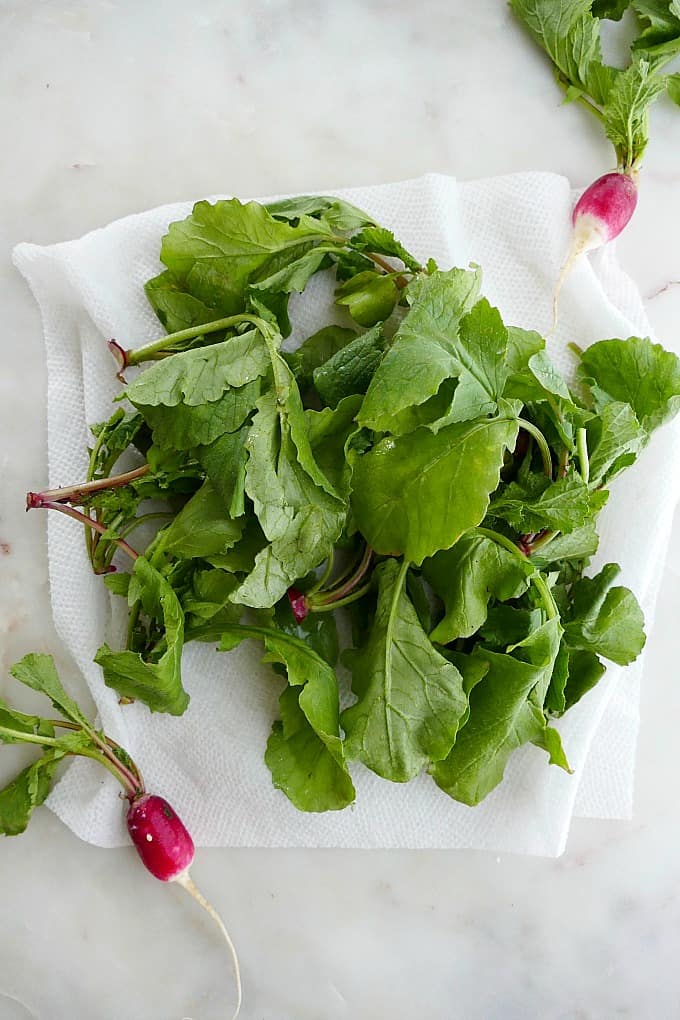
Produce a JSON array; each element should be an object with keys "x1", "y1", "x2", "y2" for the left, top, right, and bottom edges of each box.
[{"x1": 553, "y1": 170, "x2": 637, "y2": 329}]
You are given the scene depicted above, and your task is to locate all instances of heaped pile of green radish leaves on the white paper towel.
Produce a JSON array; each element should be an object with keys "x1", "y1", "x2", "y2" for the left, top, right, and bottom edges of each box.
[{"x1": 9, "y1": 189, "x2": 680, "y2": 831}]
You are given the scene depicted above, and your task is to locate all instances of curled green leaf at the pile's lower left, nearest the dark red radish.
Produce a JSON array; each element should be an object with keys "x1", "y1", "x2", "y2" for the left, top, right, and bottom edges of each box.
[{"x1": 95, "y1": 556, "x2": 189, "y2": 715}]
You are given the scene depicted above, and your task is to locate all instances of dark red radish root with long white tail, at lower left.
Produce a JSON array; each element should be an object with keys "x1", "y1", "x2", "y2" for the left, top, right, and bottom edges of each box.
[{"x1": 127, "y1": 791, "x2": 242, "y2": 1020}]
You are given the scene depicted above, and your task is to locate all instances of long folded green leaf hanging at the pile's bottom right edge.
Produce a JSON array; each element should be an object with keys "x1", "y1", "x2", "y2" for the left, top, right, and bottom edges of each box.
[{"x1": 430, "y1": 619, "x2": 561, "y2": 805}]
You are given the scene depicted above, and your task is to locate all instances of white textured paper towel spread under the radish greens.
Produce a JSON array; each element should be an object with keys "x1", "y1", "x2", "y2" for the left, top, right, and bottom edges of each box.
[{"x1": 14, "y1": 173, "x2": 680, "y2": 856}]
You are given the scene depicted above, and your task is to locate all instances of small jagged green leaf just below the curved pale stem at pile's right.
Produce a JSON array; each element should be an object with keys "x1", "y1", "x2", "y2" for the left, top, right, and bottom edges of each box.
[{"x1": 489, "y1": 471, "x2": 591, "y2": 534}]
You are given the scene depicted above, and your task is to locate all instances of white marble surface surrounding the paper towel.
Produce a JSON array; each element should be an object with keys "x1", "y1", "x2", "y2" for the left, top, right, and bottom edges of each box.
[{"x1": 0, "y1": 0, "x2": 680, "y2": 1020}]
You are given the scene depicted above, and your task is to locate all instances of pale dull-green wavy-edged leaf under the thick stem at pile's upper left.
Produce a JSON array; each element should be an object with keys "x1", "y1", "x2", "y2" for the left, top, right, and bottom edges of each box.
[{"x1": 124, "y1": 329, "x2": 270, "y2": 408}]
